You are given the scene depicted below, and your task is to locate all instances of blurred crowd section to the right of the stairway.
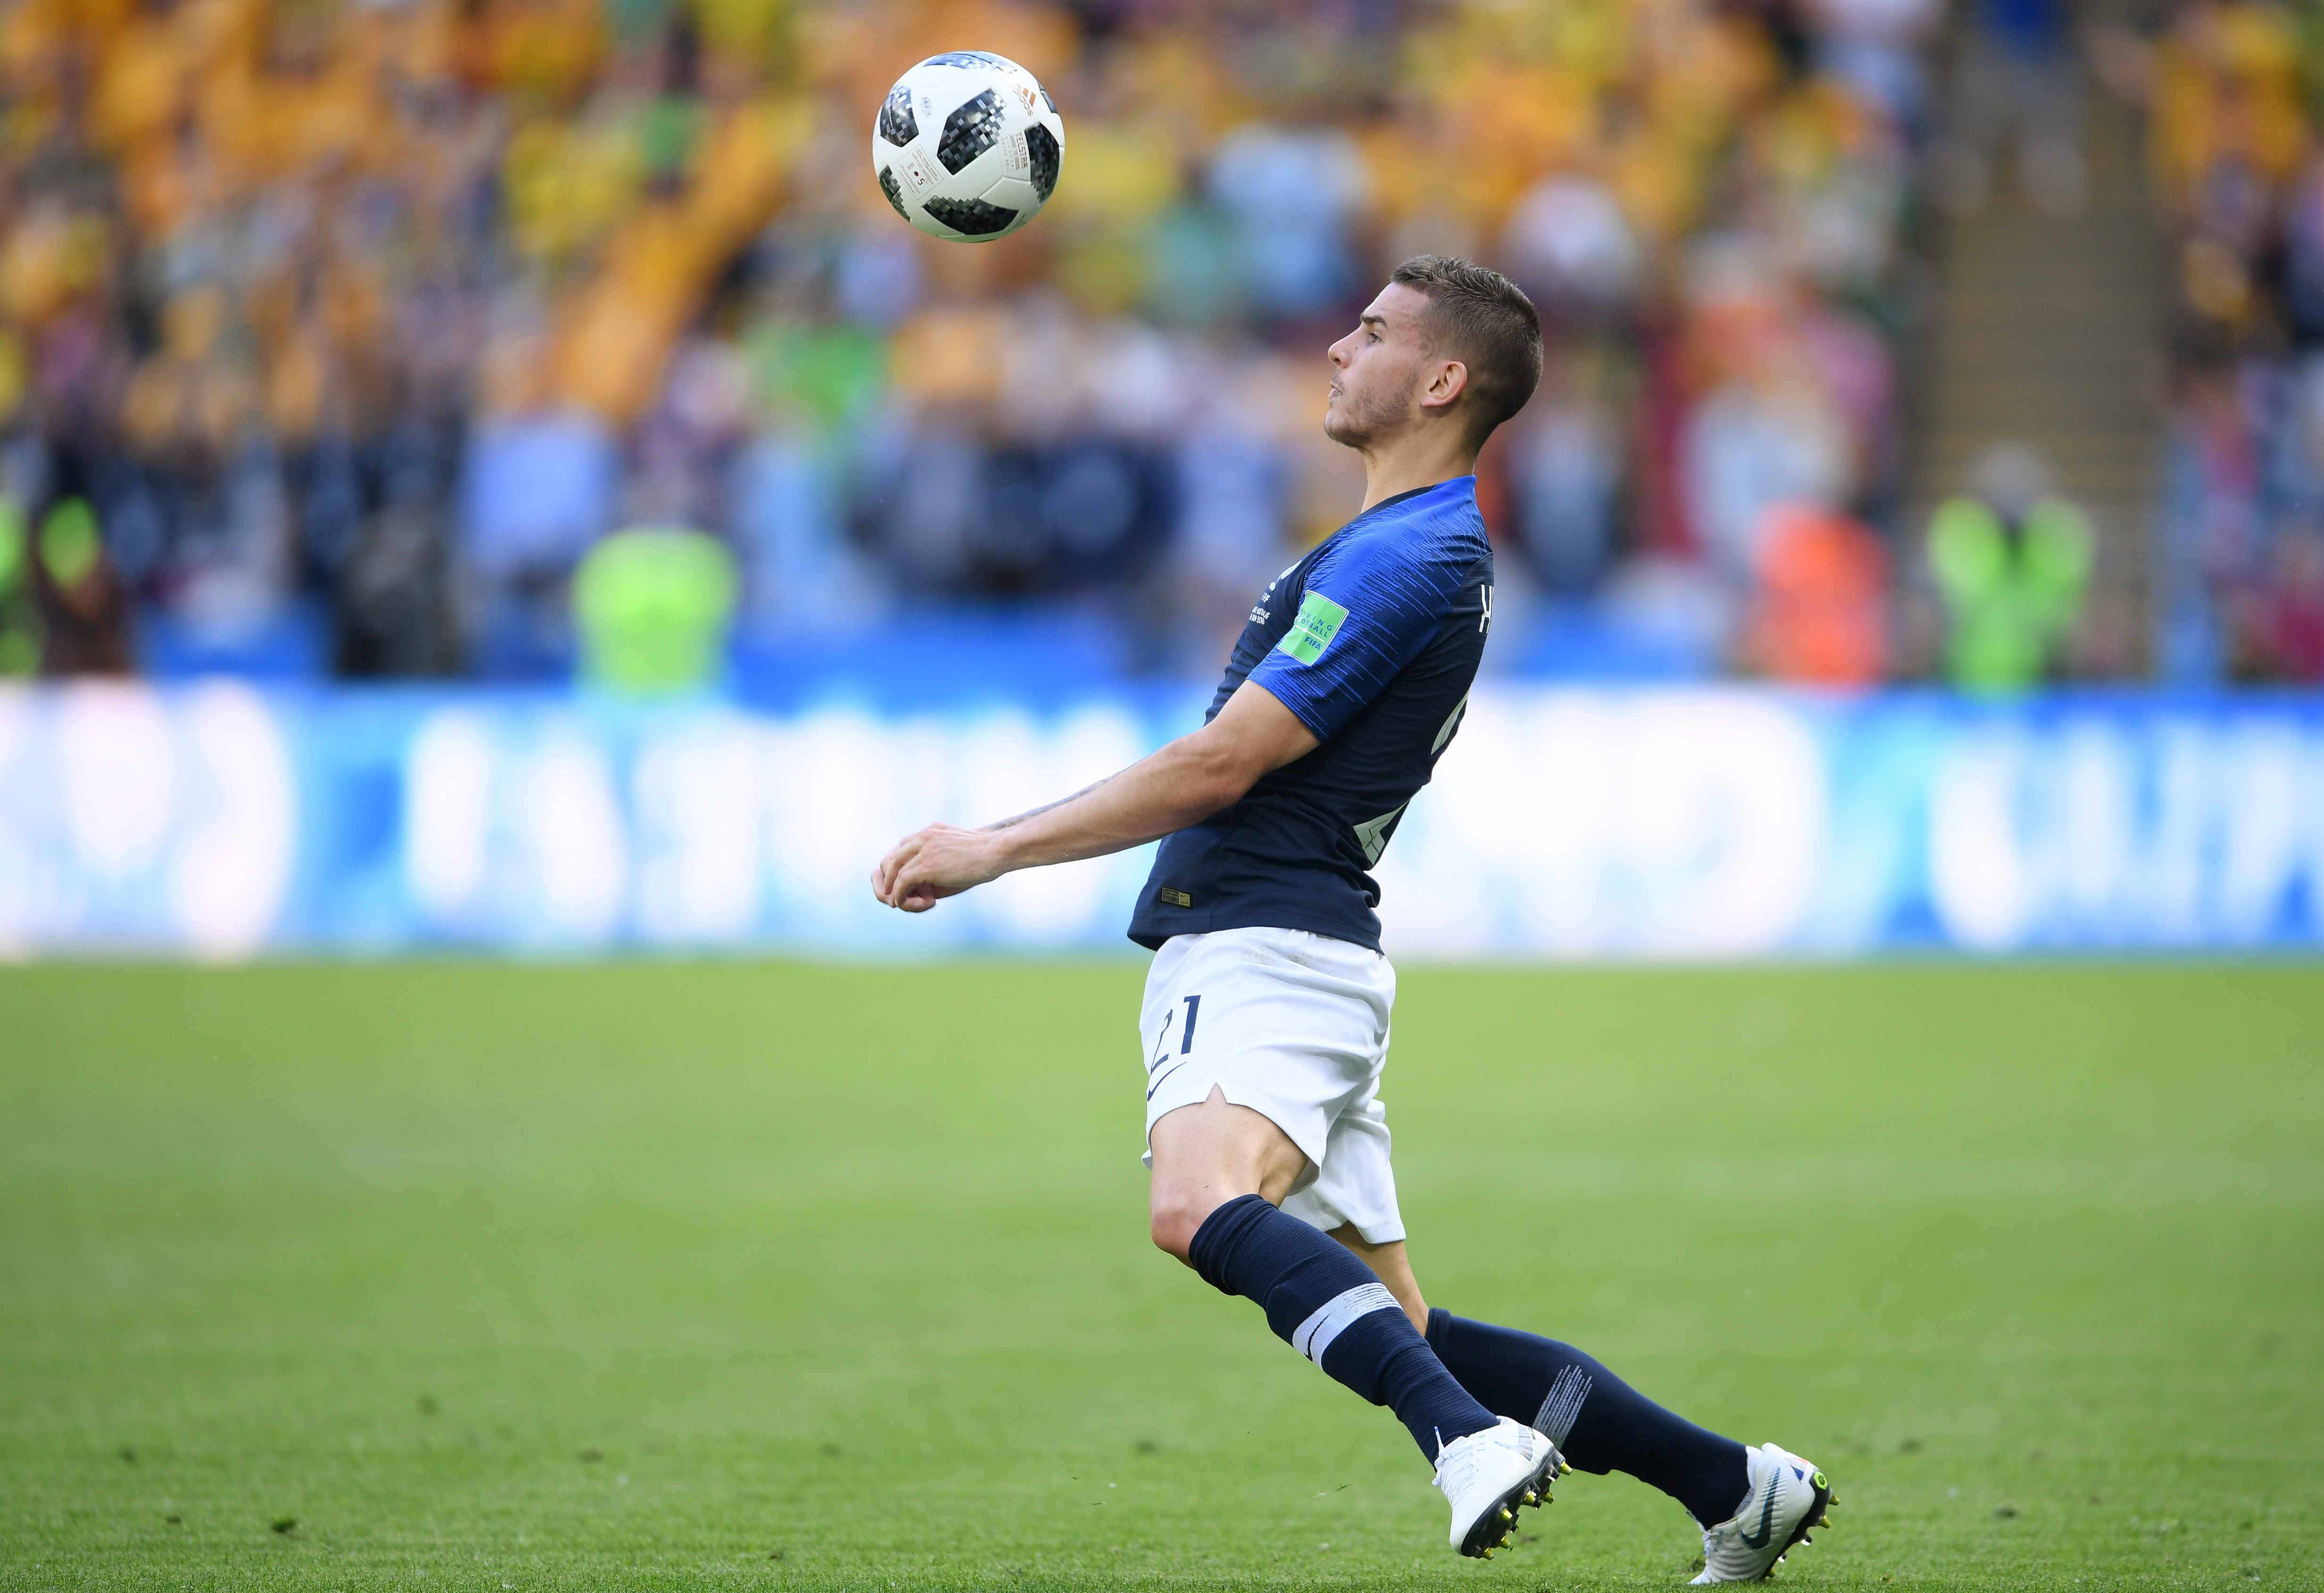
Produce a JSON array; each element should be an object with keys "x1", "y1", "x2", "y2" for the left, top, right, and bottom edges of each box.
[{"x1": 2106, "y1": 2, "x2": 2324, "y2": 686}]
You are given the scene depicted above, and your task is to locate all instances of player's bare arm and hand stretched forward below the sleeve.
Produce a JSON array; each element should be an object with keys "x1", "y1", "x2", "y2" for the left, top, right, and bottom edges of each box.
[{"x1": 871, "y1": 681, "x2": 1315, "y2": 912}]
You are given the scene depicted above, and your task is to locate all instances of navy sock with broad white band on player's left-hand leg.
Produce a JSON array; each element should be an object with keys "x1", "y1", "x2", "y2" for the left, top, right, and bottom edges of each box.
[{"x1": 1188, "y1": 1195, "x2": 1494, "y2": 1465}]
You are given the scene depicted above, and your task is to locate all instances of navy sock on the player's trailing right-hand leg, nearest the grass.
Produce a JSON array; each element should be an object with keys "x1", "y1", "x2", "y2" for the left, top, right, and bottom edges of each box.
[{"x1": 1429, "y1": 1311, "x2": 1750, "y2": 1526}]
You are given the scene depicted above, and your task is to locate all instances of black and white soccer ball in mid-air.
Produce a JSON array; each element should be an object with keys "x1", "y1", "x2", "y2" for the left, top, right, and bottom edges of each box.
[{"x1": 871, "y1": 49, "x2": 1064, "y2": 244}]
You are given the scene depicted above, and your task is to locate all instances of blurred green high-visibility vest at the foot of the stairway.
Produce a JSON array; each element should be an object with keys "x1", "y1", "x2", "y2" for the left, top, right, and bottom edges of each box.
[{"x1": 1929, "y1": 498, "x2": 2092, "y2": 695}]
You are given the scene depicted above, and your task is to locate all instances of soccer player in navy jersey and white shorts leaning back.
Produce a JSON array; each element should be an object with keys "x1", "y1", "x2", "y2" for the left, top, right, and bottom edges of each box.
[{"x1": 871, "y1": 256, "x2": 1831, "y2": 1581}]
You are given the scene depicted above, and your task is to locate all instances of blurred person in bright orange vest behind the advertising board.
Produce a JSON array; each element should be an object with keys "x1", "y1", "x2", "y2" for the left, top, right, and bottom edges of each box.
[{"x1": 1750, "y1": 505, "x2": 1889, "y2": 689}]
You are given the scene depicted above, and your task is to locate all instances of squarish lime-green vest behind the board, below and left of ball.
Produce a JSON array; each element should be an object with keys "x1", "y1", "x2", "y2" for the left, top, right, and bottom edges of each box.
[{"x1": 574, "y1": 528, "x2": 735, "y2": 693}]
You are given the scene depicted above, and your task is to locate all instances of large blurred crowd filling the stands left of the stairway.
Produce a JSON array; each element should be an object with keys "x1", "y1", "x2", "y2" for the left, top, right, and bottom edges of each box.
[{"x1": 0, "y1": 0, "x2": 1970, "y2": 684}]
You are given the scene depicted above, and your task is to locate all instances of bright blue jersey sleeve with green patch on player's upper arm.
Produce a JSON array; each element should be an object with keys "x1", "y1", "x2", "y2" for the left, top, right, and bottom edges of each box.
[{"x1": 1250, "y1": 537, "x2": 1459, "y2": 742}]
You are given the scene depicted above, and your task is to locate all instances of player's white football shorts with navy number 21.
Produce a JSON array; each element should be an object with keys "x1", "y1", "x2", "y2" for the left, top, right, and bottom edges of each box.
[{"x1": 1139, "y1": 928, "x2": 1404, "y2": 1244}]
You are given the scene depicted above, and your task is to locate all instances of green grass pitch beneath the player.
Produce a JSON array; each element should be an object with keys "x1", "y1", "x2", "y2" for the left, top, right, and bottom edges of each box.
[{"x1": 0, "y1": 963, "x2": 2324, "y2": 1593}]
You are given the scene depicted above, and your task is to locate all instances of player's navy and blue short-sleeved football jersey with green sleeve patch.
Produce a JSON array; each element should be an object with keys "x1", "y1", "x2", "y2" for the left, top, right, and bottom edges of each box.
[{"x1": 1129, "y1": 477, "x2": 1492, "y2": 951}]
